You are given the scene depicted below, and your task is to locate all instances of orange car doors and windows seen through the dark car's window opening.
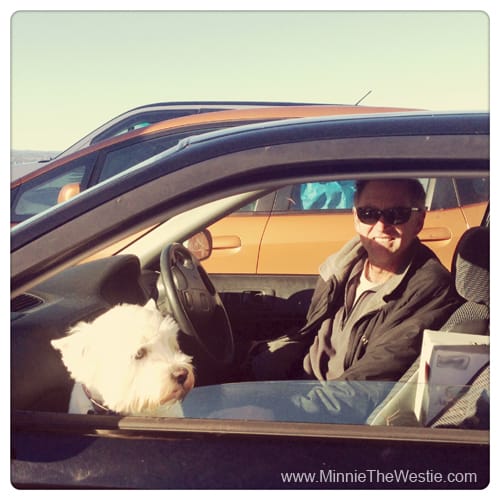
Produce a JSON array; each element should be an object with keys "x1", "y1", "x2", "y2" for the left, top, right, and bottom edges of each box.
[{"x1": 203, "y1": 178, "x2": 489, "y2": 274}]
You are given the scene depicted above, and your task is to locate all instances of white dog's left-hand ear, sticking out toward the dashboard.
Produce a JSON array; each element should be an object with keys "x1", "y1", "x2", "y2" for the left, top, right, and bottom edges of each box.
[{"x1": 50, "y1": 321, "x2": 94, "y2": 382}]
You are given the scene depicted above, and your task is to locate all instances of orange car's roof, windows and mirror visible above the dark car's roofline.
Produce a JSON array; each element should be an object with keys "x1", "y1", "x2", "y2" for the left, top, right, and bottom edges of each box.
[{"x1": 11, "y1": 105, "x2": 414, "y2": 224}]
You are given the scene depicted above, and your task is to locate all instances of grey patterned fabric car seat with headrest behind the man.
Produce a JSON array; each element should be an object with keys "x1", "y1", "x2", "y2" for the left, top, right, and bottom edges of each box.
[{"x1": 367, "y1": 227, "x2": 490, "y2": 428}]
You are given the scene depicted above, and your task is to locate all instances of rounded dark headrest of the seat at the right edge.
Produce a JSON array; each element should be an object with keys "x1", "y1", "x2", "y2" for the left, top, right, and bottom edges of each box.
[{"x1": 452, "y1": 227, "x2": 490, "y2": 305}]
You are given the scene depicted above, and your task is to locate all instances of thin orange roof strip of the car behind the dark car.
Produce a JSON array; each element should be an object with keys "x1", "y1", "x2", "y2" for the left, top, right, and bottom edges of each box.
[{"x1": 11, "y1": 104, "x2": 413, "y2": 188}]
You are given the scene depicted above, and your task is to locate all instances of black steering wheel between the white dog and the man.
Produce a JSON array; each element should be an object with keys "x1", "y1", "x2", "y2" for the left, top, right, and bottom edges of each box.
[{"x1": 160, "y1": 243, "x2": 234, "y2": 365}]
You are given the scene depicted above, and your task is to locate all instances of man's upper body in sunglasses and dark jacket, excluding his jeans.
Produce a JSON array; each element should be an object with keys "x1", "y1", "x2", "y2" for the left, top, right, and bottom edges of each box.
[{"x1": 253, "y1": 179, "x2": 459, "y2": 381}]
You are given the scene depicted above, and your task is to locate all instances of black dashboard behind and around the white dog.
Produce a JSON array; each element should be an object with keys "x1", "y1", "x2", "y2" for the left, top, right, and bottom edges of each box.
[{"x1": 11, "y1": 255, "x2": 157, "y2": 411}]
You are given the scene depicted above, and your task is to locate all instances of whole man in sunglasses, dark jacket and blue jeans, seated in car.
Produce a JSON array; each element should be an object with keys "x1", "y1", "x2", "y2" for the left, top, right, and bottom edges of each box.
[{"x1": 185, "y1": 179, "x2": 460, "y2": 424}]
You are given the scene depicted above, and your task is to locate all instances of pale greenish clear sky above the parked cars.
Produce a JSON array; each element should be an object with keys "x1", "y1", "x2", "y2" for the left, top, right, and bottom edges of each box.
[{"x1": 10, "y1": 2, "x2": 491, "y2": 150}]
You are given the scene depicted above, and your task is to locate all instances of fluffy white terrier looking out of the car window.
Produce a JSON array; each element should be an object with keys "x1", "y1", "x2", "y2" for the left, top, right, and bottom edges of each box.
[{"x1": 51, "y1": 300, "x2": 194, "y2": 417}]
